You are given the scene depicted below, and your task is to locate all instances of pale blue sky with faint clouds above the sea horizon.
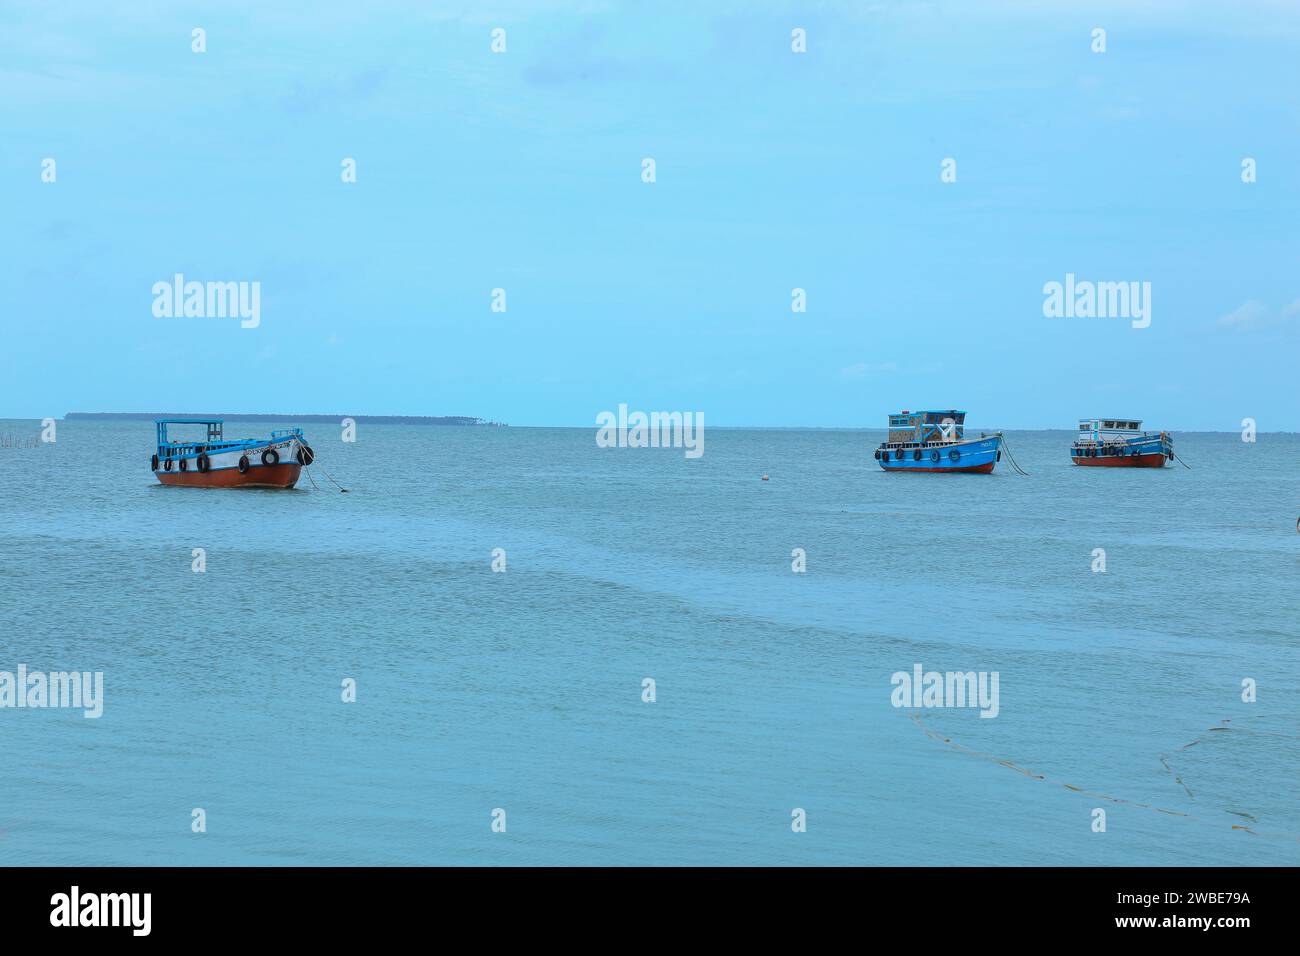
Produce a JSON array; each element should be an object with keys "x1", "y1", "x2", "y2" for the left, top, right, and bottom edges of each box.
[{"x1": 0, "y1": 0, "x2": 1300, "y2": 431}]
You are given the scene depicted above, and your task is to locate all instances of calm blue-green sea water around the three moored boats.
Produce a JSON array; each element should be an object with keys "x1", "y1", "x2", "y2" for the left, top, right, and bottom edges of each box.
[{"x1": 0, "y1": 421, "x2": 1300, "y2": 865}]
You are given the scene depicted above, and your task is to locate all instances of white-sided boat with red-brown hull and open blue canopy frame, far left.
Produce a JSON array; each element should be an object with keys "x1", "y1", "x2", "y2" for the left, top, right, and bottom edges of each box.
[{"x1": 150, "y1": 419, "x2": 315, "y2": 488}]
